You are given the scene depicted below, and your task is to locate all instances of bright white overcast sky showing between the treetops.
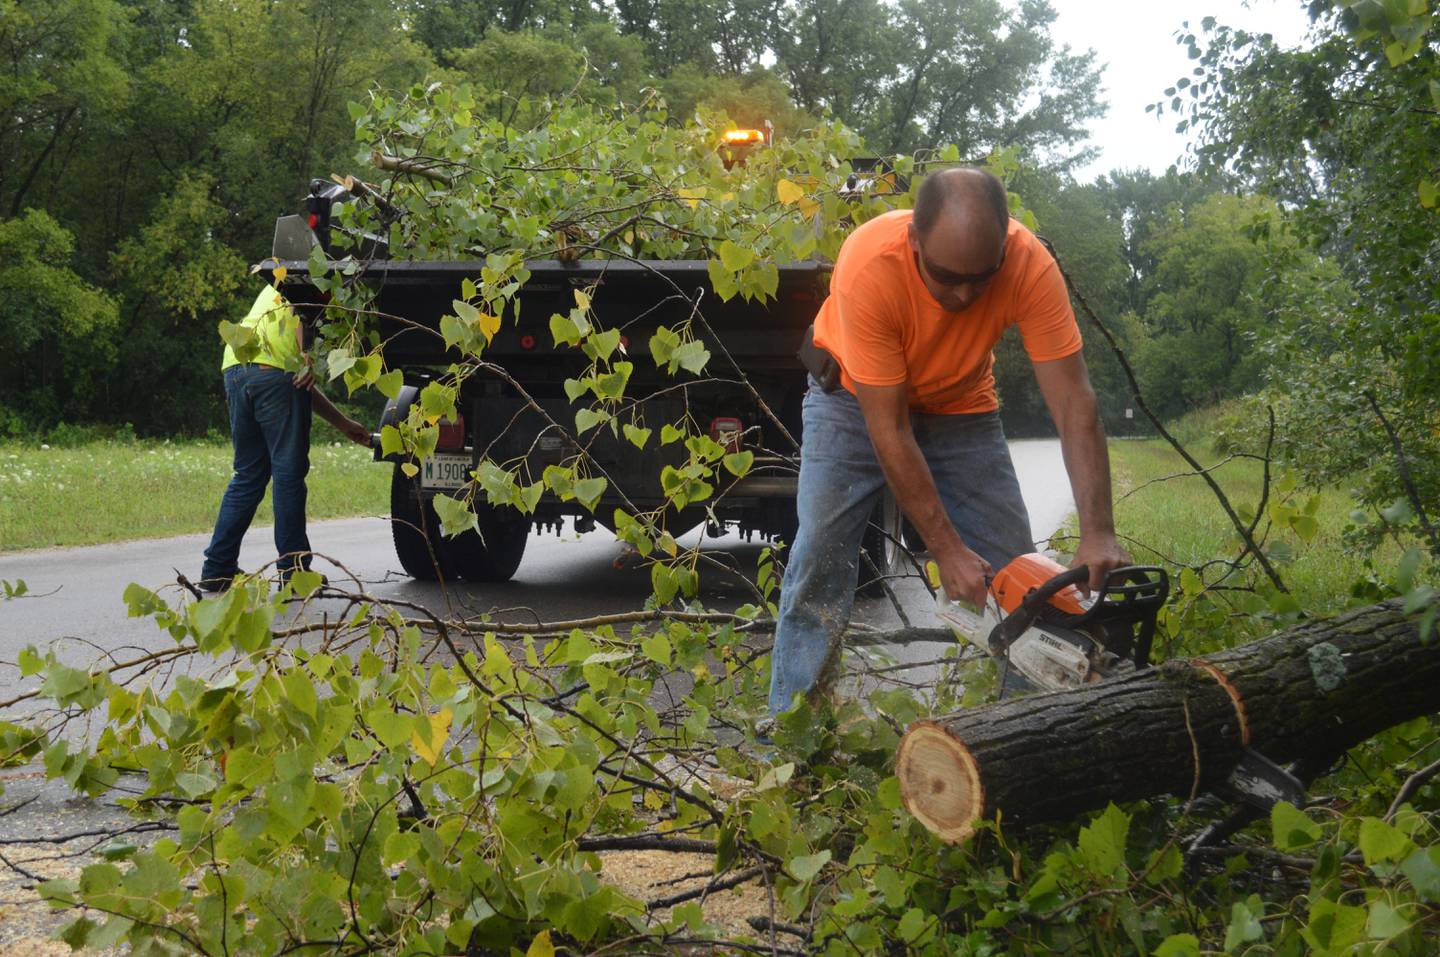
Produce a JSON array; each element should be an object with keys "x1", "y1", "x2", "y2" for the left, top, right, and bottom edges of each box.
[{"x1": 1050, "y1": 0, "x2": 1309, "y2": 181}]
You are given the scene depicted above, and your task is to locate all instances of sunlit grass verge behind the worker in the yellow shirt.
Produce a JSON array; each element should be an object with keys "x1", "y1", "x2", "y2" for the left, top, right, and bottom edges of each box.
[{"x1": 0, "y1": 440, "x2": 390, "y2": 551}]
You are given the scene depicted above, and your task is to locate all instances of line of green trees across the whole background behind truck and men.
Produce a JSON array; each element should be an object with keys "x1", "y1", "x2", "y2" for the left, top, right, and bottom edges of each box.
[{"x1": 0, "y1": 0, "x2": 1440, "y2": 538}]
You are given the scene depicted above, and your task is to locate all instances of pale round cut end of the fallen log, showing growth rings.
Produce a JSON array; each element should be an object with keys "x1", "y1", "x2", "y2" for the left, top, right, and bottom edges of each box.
[{"x1": 896, "y1": 721, "x2": 985, "y2": 843}]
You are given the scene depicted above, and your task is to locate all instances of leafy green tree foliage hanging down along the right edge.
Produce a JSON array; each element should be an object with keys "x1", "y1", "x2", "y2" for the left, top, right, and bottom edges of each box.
[{"x1": 1168, "y1": 0, "x2": 1440, "y2": 548}]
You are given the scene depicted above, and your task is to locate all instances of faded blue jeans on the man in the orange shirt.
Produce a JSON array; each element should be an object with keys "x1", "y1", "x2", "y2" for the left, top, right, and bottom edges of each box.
[{"x1": 770, "y1": 378, "x2": 1034, "y2": 714}]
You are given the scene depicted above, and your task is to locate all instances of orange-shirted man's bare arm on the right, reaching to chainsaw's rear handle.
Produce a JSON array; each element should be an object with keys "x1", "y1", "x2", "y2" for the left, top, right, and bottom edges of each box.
[{"x1": 1035, "y1": 353, "x2": 1130, "y2": 591}]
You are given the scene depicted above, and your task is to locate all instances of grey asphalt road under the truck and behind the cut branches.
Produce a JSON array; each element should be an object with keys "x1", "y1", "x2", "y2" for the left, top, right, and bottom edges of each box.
[{"x1": 0, "y1": 440, "x2": 1074, "y2": 702}]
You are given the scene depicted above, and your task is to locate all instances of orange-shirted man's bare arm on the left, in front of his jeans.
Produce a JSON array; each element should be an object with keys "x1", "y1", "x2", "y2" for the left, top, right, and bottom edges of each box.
[{"x1": 855, "y1": 383, "x2": 991, "y2": 604}]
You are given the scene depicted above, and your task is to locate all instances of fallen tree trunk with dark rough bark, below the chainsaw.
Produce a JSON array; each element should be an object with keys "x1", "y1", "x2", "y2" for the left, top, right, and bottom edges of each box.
[{"x1": 896, "y1": 602, "x2": 1440, "y2": 842}]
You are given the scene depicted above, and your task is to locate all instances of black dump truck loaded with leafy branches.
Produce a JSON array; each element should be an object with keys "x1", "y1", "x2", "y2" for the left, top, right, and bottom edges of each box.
[{"x1": 259, "y1": 180, "x2": 904, "y2": 583}]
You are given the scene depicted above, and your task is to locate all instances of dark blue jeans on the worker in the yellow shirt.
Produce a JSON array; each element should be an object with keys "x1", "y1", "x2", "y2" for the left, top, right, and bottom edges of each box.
[{"x1": 200, "y1": 364, "x2": 310, "y2": 579}]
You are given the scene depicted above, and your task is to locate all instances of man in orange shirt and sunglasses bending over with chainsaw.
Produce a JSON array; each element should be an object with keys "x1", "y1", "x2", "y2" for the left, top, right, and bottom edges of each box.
[{"x1": 770, "y1": 168, "x2": 1129, "y2": 714}]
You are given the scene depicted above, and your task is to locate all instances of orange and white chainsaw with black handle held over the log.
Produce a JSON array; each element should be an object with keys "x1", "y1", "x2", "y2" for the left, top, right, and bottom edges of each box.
[{"x1": 936, "y1": 553, "x2": 1169, "y2": 691}]
